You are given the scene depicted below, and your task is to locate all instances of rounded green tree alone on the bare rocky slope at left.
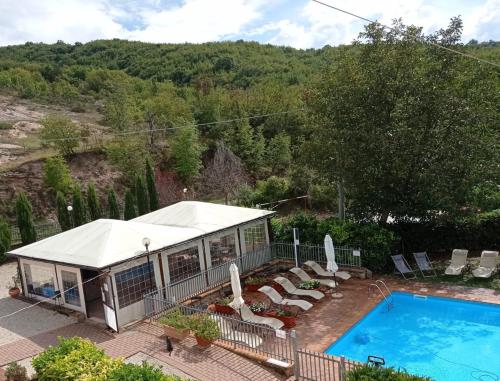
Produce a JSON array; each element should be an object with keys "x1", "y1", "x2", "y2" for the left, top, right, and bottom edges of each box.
[{"x1": 40, "y1": 114, "x2": 81, "y2": 157}]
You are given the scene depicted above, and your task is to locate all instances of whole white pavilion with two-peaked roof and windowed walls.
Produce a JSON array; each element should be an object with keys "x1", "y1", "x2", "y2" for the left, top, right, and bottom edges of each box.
[{"x1": 9, "y1": 201, "x2": 274, "y2": 330}]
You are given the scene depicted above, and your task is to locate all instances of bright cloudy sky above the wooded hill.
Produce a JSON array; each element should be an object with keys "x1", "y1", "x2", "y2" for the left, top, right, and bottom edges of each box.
[{"x1": 0, "y1": 0, "x2": 500, "y2": 49}]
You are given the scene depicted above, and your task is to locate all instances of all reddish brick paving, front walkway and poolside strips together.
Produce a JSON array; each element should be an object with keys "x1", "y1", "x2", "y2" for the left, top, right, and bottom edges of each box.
[{"x1": 0, "y1": 277, "x2": 500, "y2": 381}]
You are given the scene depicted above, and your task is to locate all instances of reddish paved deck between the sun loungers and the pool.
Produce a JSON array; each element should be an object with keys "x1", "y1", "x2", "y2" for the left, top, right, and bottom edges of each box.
[{"x1": 295, "y1": 277, "x2": 500, "y2": 352}]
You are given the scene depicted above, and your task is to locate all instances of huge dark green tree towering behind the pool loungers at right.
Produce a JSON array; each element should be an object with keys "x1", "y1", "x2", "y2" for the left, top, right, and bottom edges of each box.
[{"x1": 306, "y1": 19, "x2": 500, "y2": 221}]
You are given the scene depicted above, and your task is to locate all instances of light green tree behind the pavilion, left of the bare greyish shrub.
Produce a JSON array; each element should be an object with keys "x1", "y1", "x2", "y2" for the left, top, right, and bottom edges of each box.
[{"x1": 171, "y1": 126, "x2": 203, "y2": 184}]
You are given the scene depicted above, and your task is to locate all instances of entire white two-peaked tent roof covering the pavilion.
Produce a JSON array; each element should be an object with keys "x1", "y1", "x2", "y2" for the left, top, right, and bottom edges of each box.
[{"x1": 9, "y1": 201, "x2": 274, "y2": 269}]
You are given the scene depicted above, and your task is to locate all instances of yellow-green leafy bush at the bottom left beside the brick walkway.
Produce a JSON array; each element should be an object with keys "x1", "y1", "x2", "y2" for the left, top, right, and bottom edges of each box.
[{"x1": 32, "y1": 337, "x2": 122, "y2": 381}]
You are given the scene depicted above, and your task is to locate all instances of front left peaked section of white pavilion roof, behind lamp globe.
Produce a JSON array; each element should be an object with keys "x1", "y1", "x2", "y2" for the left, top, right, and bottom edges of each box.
[{"x1": 10, "y1": 219, "x2": 200, "y2": 268}]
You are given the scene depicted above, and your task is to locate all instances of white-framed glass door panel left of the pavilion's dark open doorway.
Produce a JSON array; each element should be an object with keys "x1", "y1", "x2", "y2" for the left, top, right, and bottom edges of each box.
[{"x1": 57, "y1": 266, "x2": 85, "y2": 313}]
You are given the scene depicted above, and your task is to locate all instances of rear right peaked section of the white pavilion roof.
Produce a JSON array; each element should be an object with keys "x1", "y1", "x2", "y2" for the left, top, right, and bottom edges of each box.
[{"x1": 132, "y1": 201, "x2": 274, "y2": 234}]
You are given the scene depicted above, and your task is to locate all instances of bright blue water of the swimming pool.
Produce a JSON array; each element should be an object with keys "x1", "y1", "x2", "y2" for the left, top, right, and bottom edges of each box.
[{"x1": 325, "y1": 292, "x2": 500, "y2": 381}]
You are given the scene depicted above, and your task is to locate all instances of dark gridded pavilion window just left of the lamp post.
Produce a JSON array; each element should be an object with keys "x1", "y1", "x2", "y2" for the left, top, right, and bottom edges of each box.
[{"x1": 115, "y1": 262, "x2": 156, "y2": 308}]
